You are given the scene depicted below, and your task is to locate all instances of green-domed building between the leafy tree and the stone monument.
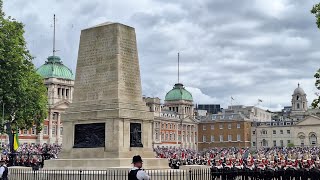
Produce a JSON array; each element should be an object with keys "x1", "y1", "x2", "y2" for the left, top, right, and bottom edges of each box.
[{"x1": 3, "y1": 56, "x2": 74, "y2": 144}]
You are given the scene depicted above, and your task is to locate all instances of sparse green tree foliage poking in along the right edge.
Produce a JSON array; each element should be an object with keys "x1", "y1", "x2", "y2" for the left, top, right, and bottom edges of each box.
[{"x1": 311, "y1": 3, "x2": 320, "y2": 108}]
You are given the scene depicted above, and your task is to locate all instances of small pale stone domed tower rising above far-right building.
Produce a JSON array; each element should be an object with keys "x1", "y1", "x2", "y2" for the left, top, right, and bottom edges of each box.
[{"x1": 291, "y1": 84, "x2": 308, "y2": 112}]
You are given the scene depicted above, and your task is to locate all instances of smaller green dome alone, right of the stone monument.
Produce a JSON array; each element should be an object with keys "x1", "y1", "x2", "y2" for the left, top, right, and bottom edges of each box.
[{"x1": 165, "y1": 83, "x2": 193, "y2": 101}]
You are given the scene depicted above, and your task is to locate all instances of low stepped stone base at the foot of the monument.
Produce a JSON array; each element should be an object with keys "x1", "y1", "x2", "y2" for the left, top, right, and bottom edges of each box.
[{"x1": 44, "y1": 158, "x2": 169, "y2": 170}]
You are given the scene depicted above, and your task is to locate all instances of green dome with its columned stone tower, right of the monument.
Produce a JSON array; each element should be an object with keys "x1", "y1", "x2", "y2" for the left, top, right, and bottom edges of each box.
[{"x1": 164, "y1": 83, "x2": 193, "y2": 118}]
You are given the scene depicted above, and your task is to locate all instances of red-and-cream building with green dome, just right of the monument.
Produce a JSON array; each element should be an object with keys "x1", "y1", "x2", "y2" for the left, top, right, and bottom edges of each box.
[{"x1": 144, "y1": 83, "x2": 198, "y2": 149}]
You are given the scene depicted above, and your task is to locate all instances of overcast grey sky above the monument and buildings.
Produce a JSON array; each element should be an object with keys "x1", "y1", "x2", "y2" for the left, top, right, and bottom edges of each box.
[{"x1": 4, "y1": 0, "x2": 320, "y2": 110}]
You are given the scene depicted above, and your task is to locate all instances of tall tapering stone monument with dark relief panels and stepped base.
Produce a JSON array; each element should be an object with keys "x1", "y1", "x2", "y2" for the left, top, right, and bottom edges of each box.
[{"x1": 45, "y1": 23, "x2": 168, "y2": 169}]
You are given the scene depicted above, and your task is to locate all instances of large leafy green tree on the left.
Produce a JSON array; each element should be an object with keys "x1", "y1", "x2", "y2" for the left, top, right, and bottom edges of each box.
[{"x1": 0, "y1": 0, "x2": 47, "y2": 132}]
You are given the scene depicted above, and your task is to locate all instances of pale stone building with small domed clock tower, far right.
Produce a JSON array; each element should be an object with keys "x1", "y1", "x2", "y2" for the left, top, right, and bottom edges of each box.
[{"x1": 251, "y1": 84, "x2": 320, "y2": 148}]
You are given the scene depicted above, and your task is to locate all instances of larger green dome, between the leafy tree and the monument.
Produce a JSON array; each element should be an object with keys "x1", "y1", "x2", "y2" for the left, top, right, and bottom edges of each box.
[{"x1": 37, "y1": 56, "x2": 74, "y2": 80}]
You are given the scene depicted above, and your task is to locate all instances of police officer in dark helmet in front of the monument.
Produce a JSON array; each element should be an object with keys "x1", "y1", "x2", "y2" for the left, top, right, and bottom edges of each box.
[{"x1": 128, "y1": 155, "x2": 150, "y2": 180}]
